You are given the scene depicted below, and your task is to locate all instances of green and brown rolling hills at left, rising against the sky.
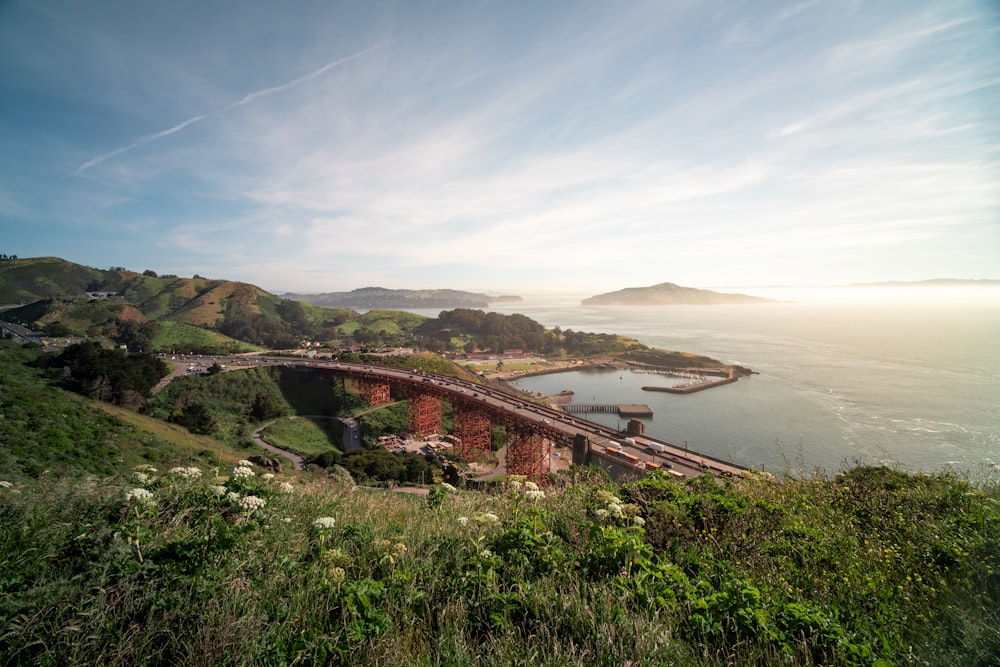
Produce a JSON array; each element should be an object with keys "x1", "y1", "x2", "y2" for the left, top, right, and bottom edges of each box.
[{"x1": 0, "y1": 257, "x2": 423, "y2": 352}]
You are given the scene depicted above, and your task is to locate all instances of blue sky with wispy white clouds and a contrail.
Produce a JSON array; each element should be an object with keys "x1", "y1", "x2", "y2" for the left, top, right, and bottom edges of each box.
[{"x1": 0, "y1": 0, "x2": 1000, "y2": 294}]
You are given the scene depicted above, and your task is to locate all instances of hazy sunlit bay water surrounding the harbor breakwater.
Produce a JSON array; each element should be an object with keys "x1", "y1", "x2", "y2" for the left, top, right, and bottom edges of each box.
[{"x1": 464, "y1": 290, "x2": 1000, "y2": 476}]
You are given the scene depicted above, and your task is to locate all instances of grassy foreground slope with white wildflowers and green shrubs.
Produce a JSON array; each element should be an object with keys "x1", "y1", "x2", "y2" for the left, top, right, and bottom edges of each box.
[{"x1": 0, "y1": 468, "x2": 1000, "y2": 665}]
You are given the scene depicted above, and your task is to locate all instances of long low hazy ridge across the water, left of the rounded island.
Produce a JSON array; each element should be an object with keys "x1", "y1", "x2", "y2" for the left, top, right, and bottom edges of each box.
[{"x1": 282, "y1": 287, "x2": 521, "y2": 310}]
